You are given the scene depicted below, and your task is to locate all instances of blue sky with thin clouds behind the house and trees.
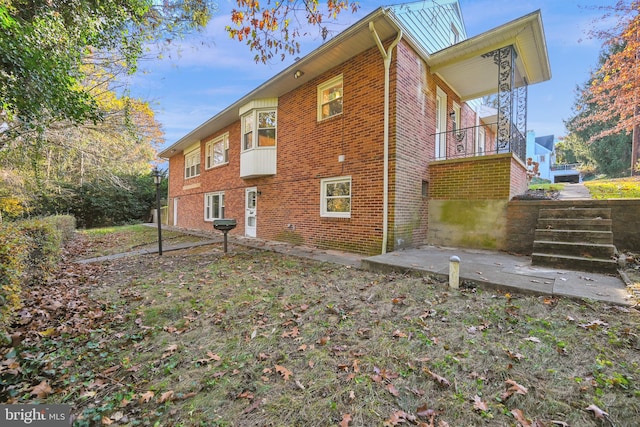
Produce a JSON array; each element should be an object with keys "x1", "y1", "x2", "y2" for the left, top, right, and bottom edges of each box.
[{"x1": 130, "y1": 0, "x2": 615, "y2": 154}]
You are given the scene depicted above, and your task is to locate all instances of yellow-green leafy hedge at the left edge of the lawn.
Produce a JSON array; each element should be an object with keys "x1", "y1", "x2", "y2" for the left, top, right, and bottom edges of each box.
[{"x1": 0, "y1": 215, "x2": 75, "y2": 340}]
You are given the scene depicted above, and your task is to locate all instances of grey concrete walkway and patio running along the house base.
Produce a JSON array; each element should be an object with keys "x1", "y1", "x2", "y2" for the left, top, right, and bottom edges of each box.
[{"x1": 79, "y1": 227, "x2": 638, "y2": 306}]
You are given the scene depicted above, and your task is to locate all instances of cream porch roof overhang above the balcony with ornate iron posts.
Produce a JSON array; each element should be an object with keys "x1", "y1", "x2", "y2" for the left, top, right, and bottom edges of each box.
[{"x1": 427, "y1": 10, "x2": 551, "y2": 101}]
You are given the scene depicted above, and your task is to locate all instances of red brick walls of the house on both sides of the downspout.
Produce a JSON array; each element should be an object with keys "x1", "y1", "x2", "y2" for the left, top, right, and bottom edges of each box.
[{"x1": 169, "y1": 37, "x2": 496, "y2": 254}]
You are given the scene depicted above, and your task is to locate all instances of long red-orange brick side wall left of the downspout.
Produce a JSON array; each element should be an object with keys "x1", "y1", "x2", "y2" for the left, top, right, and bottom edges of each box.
[{"x1": 169, "y1": 48, "x2": 384, "y2": 254}]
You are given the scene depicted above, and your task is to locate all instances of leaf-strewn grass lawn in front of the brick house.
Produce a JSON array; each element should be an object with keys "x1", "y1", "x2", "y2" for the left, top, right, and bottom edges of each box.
[{"x1": 0, "y1": 229, "x2": 640, "y2": 427}]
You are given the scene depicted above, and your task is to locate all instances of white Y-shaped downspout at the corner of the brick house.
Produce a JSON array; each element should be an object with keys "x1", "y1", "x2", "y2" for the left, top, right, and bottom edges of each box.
[{"x1": 369, "y1": 22, "x2": 402, "y2": 254}]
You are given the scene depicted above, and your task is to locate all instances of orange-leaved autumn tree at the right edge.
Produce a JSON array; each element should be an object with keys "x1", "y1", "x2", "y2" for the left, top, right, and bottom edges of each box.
[{"x1": 576, "y1": 0, "x2": 640, "y2": 173}]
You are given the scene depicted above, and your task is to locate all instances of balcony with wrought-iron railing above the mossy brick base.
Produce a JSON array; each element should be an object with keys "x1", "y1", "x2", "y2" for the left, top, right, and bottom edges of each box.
[{"x1": 433, "y1": 123, "x2": 527, "y2": 162}]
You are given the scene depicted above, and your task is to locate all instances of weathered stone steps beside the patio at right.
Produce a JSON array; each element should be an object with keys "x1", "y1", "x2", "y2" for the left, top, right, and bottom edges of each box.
[{"x1": 532, "y1": 207, "x2": 618, "y2": 273}]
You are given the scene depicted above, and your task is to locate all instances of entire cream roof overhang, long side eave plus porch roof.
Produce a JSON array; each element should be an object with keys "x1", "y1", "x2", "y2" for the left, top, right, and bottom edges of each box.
[{"x1": 159, "y1": 8, "x2": 551, "y2": 158}]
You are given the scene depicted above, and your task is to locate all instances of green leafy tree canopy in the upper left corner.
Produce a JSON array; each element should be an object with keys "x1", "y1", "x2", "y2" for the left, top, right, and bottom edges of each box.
[{"x1": 0, "y1": 0, "x2": 212, "y2": 148}]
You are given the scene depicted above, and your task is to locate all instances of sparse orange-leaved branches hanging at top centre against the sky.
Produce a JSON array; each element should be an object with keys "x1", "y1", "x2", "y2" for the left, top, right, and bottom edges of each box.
[{"x1": 226, "y1": 0, "x2": 359, "y2": 63}]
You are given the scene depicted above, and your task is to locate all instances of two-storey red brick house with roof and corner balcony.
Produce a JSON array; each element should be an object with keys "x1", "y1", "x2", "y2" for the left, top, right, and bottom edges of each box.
[{"x1": 160, "y1": 0, "x2": 550, "y2": 254}]
